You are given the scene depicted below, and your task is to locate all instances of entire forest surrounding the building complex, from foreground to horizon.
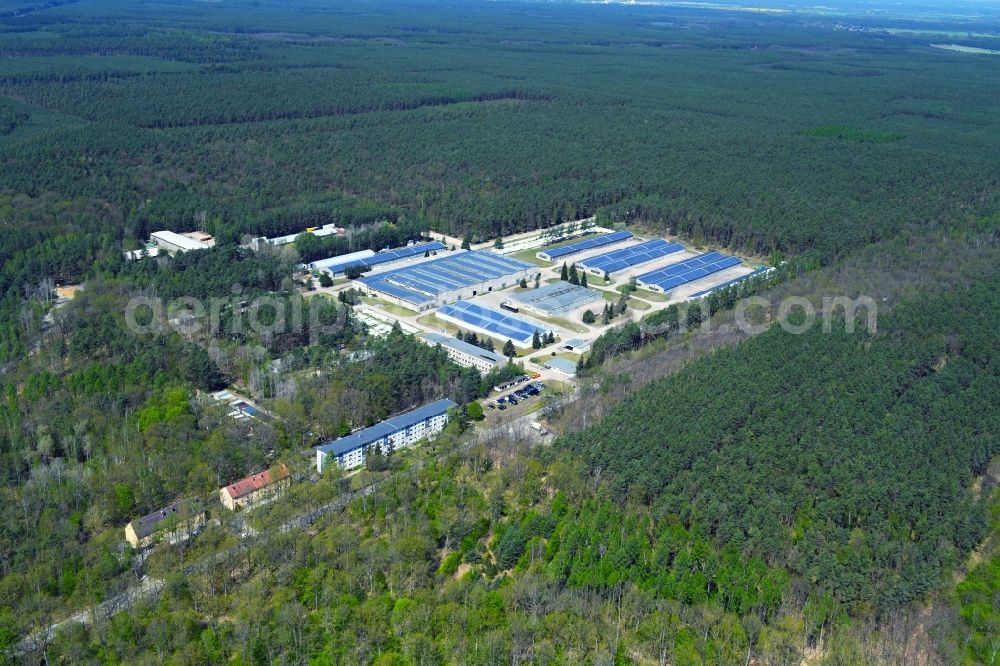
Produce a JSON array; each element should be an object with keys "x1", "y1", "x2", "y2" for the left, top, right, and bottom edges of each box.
[{"x1": 0, "y1": 0, "x2": 1000, "y2": 666}]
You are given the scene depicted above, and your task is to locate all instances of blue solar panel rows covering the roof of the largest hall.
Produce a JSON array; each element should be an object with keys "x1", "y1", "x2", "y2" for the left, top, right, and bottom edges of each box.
[{"x1": 359, "y1": 250, "x2": 534, "y2": 304}]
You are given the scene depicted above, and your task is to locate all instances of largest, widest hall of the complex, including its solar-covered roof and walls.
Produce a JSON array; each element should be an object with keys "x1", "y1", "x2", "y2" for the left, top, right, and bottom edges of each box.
[{"x1": 357, "y1": 250, "x2": 539, "y2": 312}]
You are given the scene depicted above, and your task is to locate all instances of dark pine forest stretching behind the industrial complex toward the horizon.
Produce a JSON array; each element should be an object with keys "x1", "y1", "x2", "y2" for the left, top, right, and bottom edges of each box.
[{"x1": 0, "y1": 2, "x2": 1000, "y2": 256}]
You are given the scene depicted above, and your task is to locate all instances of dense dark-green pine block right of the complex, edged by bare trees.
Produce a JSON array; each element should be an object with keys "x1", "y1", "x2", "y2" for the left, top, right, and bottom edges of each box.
[{"x1": 563, "y1": 279, "x2": 1000, "y2": 612}]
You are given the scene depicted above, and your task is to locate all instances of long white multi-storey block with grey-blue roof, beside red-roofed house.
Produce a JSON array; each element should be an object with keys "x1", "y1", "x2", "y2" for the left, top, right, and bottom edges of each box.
[{"x1": 316, "y1": 399, "x2": 457, "y2": 474}]
